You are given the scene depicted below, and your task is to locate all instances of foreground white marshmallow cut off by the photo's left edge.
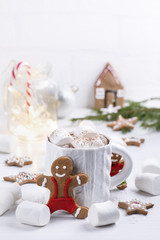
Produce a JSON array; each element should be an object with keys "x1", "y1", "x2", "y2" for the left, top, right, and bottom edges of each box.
[{"x1": 0, "y1": 183, "x2": 21, "y2": 215}]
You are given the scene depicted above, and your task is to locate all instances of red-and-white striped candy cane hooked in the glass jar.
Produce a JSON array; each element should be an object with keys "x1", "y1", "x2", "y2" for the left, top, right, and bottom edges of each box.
[{"x1": 10, "y1": 62, "x2": 31, "y2": 113}]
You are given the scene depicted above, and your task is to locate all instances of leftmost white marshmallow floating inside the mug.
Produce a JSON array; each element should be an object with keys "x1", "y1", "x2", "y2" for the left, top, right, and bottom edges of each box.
[{"x1": 49, "y1": 129, "x2": 72, "y2": 146}]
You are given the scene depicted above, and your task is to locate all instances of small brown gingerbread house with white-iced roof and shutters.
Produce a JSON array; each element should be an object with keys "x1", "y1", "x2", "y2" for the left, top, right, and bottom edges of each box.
[{"x1": 94, "y1": 63, "x2": 124, "y2": 108}]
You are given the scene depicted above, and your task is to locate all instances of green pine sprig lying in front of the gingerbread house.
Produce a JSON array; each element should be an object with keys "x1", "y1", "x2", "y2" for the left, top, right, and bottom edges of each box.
[{"x1": 71, "y1": 98, "x2": 160, "y2": 133}]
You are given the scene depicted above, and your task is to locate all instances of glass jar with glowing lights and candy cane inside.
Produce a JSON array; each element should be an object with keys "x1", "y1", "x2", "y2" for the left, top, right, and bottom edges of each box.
[{"x1": 4, "y1": 62, "x2": 57, "y2": 140}]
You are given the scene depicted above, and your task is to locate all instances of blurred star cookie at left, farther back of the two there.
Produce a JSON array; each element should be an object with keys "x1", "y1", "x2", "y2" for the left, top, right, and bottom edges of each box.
[{"x1": 5, "y1": 156, "x2": 32, "y2": 167}]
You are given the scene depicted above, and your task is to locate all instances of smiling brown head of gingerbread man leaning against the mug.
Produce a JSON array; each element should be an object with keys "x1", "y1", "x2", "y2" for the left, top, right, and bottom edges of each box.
[{"x1": 51, "y1": 157, "x2": 73, "y2": 180}]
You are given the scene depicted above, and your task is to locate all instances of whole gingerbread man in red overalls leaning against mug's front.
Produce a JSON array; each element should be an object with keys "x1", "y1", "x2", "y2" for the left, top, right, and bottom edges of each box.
[{"x1": 37, "y1": 156, "x2": 88, "y2": 219}]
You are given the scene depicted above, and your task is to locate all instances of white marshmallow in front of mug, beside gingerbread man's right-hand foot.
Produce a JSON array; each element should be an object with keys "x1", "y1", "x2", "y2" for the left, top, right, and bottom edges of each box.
[{"x1": 88, "y1": 201, "x2": 120, "y2": 227}]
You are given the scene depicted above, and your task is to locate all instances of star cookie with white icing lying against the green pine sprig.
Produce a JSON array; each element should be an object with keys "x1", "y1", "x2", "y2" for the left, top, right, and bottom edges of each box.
[{"x1": 107, "y1": 115, "x2": 138, "y2": 131}]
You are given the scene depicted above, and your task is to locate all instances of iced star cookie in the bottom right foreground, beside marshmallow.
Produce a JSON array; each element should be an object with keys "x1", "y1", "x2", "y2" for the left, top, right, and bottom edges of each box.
[{"x1": 118, "y1": 199, "x2": 154, "y2": 215}]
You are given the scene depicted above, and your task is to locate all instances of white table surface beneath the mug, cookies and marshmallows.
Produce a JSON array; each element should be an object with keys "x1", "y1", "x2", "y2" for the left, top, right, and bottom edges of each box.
[{"x1": 0, "y1": 109, "x2": 160, "y2": 240}]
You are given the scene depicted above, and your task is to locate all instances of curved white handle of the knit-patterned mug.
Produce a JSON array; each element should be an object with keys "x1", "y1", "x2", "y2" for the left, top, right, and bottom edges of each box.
[{"x1": 110, "y1": 143, "x2": 133, "y2": 188}]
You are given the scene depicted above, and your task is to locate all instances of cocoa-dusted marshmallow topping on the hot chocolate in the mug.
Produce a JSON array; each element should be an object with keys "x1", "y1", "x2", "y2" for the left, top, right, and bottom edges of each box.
[{"x1": 49, "y1": 127, "x2": 109, "y2": 149}]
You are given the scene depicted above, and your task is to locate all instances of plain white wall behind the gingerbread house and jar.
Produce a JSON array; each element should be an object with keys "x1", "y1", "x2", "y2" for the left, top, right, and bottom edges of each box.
[{"x1": 0, "y1": 0, "x2": 160, "y2": 107}]
